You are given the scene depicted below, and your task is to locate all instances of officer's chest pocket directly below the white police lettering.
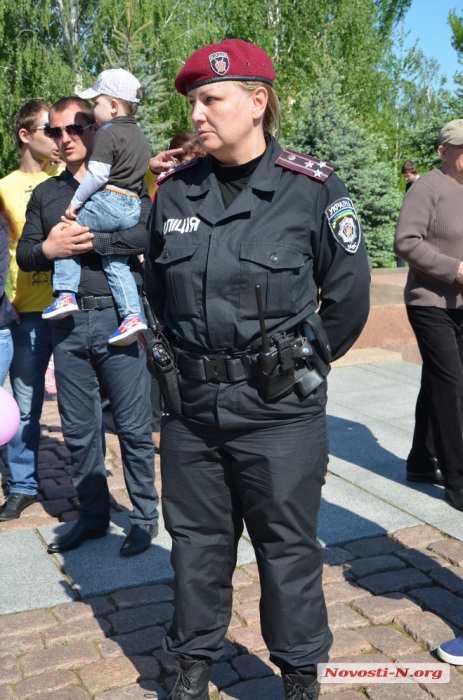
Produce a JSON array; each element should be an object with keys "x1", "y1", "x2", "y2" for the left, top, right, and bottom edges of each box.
[{"x1": 156, "y1": 243, "x2": 199, "y2": 318}]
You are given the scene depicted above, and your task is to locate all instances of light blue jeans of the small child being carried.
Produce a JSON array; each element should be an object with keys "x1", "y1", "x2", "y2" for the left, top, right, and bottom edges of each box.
[{"x1": 53, "y1": 190, "x2": 141, "y2": 318}]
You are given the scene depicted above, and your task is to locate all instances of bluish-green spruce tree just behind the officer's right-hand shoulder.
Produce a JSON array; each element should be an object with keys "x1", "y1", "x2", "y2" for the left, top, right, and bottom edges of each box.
[{"x1": 291, "y1": 58, "x2": 402, "y2": 267}]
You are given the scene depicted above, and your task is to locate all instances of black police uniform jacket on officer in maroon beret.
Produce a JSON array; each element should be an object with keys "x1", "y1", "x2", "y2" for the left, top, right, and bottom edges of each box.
[{"x1": 145, "y1": 138, "x2": 370, "y2": 424}]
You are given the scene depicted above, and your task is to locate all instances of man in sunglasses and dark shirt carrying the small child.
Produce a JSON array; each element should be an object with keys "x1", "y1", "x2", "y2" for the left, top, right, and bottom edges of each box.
[{"x1": 17, "y1": 97, "x2": 158, "y2": 556}]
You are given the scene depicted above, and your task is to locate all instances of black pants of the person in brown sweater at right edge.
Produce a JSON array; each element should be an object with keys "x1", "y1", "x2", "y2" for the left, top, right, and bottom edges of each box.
[{"x1": 407, "y1": 306, "x2": 463, "y2": 489}]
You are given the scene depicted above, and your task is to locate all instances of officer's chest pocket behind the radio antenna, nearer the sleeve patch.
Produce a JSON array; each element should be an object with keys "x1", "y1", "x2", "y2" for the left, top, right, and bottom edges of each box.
[{"x1": 240, "y1": 243, "x2": 305, "y2": 319}]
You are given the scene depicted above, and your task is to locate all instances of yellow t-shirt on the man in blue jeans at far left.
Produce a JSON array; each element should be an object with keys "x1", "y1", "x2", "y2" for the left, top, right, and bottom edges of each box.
[{"x1": 0, "y1": 165, "x2": 62, "y2": 313}]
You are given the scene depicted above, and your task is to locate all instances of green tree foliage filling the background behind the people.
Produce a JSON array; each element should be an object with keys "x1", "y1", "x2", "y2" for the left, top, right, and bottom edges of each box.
[{"x1": 0, "y1": 0, "x2": 456, "y2": 265}]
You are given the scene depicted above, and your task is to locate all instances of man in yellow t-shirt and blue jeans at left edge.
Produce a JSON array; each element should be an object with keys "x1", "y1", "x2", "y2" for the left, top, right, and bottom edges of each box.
[{"x1": 0, "y1": 100, "x2": 63, "y2": 521}]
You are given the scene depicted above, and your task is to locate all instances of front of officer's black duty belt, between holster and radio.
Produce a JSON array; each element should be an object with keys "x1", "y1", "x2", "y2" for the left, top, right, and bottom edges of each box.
[{"x1": 176, "y1": 347, "x2": 253, "y2": 384}]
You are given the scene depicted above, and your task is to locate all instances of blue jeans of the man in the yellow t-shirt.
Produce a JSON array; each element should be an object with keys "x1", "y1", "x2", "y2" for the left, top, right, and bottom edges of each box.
[{"x1": 8, "y1": 312, "x2": 51, "y2": 496}]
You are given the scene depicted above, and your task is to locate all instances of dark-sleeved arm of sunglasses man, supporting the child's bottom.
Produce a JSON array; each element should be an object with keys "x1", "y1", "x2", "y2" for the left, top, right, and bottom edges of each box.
[{"x1": 93, "y1": 183, "x2": 152, "y2": 257}]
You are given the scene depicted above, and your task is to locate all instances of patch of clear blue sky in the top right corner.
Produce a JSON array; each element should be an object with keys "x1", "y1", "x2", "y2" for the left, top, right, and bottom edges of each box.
[{"x1": 405, "y1": 0, "x2": 463, "y2": 87}]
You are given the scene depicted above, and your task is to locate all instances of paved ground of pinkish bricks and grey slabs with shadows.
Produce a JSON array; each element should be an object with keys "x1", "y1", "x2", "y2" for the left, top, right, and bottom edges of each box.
[{"x1": 0, "y1": 363, "x2": 463, "y2": 700}]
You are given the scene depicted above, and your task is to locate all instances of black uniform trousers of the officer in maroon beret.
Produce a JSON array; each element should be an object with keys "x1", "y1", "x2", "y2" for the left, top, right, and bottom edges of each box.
[{"x1": 161, "y1": 408, "x2": 332, "y2": 673}]
